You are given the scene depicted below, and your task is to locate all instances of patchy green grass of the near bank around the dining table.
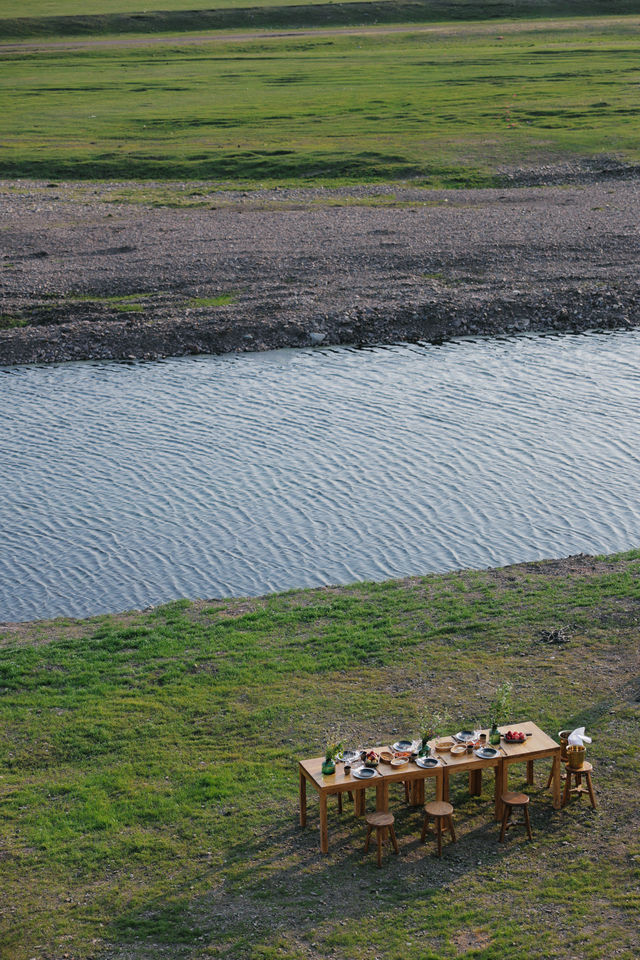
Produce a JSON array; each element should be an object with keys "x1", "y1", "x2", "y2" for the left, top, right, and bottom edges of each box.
[{"x1": 0, "y1": 551, "x2": 640, "y2": 960}]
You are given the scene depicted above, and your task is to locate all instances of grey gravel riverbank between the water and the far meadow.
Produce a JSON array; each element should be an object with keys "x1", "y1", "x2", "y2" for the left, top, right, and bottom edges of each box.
[{"x1": 0, "y1": 171, "x2": 640, "y2": 364}]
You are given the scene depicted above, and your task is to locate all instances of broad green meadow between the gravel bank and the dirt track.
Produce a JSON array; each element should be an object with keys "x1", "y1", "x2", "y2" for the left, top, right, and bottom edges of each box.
[{"x1": 0, "y1": 18, "x2": 640, "y2": 186}]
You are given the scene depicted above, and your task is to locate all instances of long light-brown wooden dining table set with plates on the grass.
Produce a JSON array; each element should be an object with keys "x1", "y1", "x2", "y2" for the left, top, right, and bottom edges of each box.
[{"x1": 298, "y1": 721, "x2": 561, "y2": 853}]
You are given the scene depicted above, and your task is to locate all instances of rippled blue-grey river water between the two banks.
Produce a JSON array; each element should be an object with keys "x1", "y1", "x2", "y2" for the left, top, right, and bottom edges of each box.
[{"x1": 0, "y1": 331, "x2": 640, "y2": 620}]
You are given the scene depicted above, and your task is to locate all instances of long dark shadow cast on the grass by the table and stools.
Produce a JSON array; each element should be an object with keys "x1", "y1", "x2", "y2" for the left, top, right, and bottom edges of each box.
[{"x1": 109, "y1": 765, "x2": 563, "y2": 958}]
